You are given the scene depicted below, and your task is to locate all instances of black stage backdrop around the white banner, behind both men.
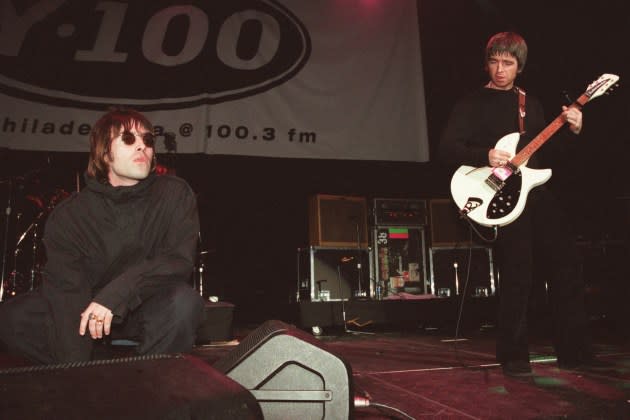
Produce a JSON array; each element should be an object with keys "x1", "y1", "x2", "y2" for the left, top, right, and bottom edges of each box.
[{"x1": 0, "y1": 0, "x2": 630, "y2": 320}]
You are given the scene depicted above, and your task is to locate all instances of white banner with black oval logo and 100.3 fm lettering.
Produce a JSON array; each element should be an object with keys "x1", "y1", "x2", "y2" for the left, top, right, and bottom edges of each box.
[{"x1": 0, "y1": 0, "x2": 429, "y2": 161}]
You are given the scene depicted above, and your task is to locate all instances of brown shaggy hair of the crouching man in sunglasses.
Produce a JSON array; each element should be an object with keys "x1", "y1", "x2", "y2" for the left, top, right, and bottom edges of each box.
[{"x1": 87, "y1": 107, "x2": 155, "y2": 184}]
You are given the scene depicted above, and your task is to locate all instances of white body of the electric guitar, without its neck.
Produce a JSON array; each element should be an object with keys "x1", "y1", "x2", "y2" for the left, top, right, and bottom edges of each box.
[{"x1": 451, "y1": 133, "x2": 551, "y2": 226}]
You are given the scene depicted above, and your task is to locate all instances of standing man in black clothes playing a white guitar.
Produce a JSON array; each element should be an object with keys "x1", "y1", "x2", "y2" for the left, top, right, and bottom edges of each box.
[{"x1": 439, "y1": 32, "x2": 595, "y2": 375}]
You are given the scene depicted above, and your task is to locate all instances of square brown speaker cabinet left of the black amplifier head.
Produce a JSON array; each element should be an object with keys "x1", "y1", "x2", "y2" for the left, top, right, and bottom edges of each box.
[{"x1": 309, "y1": 194, "x2": 368, "y2": 248}]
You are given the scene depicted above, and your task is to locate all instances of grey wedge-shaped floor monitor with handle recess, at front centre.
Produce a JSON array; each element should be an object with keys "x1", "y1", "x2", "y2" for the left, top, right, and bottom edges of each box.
[{"x1": 214, "y1": 320, "x2": 354, "y2": 420}]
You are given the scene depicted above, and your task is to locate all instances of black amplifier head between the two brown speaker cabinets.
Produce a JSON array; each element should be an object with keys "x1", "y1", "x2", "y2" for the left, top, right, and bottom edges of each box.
[{"x1": 374, "y1": 198, "x2": 427, "y2": 226}]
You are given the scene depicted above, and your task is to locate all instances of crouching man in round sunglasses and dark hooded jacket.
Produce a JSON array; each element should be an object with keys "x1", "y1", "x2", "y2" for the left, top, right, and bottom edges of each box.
[{"x1": 0, "y1": 108, "x2": 203, "y2": 363}]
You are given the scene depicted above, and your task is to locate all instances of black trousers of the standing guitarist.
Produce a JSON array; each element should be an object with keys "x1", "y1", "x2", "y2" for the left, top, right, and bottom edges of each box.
[{"x1": 496, "y1": 188, "x2": 592, "y2": 363}]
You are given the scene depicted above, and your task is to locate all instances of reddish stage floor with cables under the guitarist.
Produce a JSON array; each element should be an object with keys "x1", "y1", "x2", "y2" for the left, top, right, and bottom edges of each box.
[{"x1": 0, "y1": 322, "x2": 630, "y2": 419}]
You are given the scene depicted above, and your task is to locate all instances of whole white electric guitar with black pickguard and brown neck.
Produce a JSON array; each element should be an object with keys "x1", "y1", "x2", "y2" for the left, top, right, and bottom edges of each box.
[{"x1": 451, "y1": 74, "x2": 619, "y2": 226}]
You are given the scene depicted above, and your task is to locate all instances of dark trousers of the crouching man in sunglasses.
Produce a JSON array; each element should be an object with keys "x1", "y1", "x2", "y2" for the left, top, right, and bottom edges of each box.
[{"x1": 0, "y1": 282, "x2": 205, "y2": 364}]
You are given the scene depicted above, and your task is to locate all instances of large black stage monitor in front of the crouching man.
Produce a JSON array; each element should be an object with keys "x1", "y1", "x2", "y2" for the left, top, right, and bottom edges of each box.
[{"x1": 0, "y1": 354, "x2": 263, "y2": 420}]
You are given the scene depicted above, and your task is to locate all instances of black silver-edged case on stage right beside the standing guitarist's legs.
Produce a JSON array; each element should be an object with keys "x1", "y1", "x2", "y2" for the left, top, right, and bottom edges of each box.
[{"x1": 429, "y1": 246, "x2": 496, "y2": 297}]
